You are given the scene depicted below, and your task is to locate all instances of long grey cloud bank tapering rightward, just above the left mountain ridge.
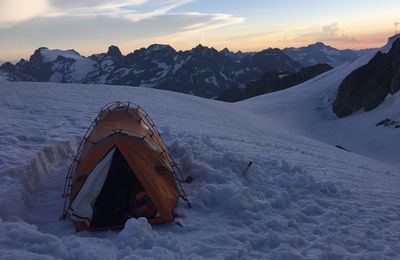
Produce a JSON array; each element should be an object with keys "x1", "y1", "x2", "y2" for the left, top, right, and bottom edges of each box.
[{"x1": 0, "y1": 11, "x2": 241, "y2": 55}]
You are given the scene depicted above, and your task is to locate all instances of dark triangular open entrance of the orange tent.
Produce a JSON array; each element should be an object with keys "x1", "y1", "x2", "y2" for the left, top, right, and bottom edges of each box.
[{"x1": 90, "y1": 149, "x2": 144, "y2": 229}]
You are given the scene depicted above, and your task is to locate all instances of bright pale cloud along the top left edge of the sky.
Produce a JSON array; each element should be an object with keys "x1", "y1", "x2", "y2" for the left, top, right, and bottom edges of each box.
[{"x1": 0, "y1": 0, "x2": 194, "y2": 24}]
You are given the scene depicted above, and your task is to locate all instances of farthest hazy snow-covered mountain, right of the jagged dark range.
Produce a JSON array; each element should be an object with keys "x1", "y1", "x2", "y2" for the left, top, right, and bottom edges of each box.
[{"x1": 283, "y1": 42, "x2": 373, "y2": 67}]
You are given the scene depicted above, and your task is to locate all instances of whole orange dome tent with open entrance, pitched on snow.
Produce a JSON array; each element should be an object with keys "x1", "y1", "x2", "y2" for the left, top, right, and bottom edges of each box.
[{"x1": 63, "y1": 102, "x2": 187, "y2": 231}]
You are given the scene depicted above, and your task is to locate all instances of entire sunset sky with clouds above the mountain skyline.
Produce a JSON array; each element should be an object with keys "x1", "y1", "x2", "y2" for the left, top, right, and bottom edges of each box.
[{"x1": 0, "y1": 0, "x2": 400, "y2": 61}]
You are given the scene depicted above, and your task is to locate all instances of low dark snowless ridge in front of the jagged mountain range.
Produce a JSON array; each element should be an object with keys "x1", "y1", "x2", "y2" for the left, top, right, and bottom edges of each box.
[{"x1": 217, "y1": 64, "x2": 333, "y2": 102}]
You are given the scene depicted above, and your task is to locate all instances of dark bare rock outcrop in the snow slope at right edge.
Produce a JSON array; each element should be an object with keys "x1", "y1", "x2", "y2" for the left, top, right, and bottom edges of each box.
[{"x1": 332, "y1": 39, "x2": 400, "y2": 117}]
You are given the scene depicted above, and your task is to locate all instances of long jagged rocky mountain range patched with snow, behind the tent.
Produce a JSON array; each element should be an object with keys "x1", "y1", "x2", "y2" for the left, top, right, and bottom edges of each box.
[{"x1": 0, "y1": 44, "x2": 302, "y2": 98}]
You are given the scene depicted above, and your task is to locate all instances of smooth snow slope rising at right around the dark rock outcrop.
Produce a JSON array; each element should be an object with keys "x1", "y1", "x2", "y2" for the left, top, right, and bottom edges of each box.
[{"x1": 238, "y1": 35, "x2": 400, "y2": 166}]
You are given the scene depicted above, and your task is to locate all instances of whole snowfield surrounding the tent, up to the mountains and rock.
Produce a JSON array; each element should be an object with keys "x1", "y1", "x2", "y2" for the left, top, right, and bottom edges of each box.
[{"x1": 0, "y1": 36, "x2": 400, "y2": 259}]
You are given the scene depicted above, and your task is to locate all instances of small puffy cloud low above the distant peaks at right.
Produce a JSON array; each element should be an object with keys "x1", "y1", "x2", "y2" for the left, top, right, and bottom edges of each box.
[{"x1": 295, "y1": 23, "x2": 357, "y2": 42}]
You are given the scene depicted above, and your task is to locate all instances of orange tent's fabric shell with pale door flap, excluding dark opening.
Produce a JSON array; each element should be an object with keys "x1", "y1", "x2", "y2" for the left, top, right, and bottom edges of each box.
[{"x1": 65, "y1": 103, "x2": 180, "y2": 230}]
